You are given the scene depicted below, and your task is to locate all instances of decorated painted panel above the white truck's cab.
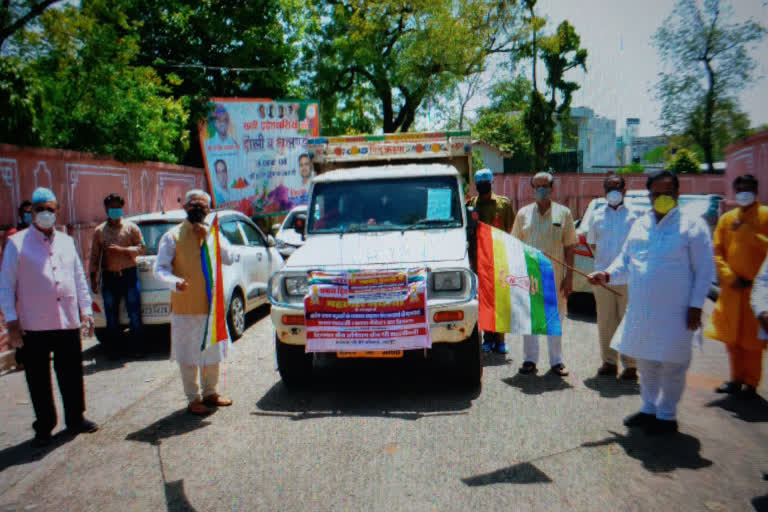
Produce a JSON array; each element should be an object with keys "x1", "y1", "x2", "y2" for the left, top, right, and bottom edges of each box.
[{"x1": 309, "y1": 131, "x2": 472, "y2": 164}]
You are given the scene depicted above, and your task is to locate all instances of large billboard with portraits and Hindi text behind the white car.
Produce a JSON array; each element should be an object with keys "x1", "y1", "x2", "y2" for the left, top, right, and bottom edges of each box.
[{"x1": 199, "y1": 98, "x2": 320, "y2": 217}]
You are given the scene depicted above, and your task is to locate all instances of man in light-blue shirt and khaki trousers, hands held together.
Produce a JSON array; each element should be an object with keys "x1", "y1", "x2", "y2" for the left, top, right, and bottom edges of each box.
[{"x1": 587, "y1": 174, "x2": 639, "y2": 381}]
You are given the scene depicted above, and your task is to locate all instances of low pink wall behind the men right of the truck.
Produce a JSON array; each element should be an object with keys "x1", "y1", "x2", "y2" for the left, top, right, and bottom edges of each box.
[{"x1": 486, "y1": 174, "x2": 732, "y2": 219}]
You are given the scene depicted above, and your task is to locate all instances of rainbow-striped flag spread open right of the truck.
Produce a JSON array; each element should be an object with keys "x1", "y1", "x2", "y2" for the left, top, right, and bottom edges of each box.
[{"x1": 477, "y1": 222, "x2": 562, "y2": 335}]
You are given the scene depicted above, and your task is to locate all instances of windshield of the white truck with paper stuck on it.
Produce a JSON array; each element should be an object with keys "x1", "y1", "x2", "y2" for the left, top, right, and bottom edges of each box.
[{"x1": 308, "y1": 176, "x2": 463, "y2": 233}]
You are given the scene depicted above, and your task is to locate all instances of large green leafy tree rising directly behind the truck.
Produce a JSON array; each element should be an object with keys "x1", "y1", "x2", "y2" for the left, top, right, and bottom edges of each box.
[{"x1": 302, "y1": 0, "x2": 517, "y2": 133}]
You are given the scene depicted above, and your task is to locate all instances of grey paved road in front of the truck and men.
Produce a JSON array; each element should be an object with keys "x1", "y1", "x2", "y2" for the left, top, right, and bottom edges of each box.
[{"x1": 0, "y1": 305, "x2": 768, "y2": 512}]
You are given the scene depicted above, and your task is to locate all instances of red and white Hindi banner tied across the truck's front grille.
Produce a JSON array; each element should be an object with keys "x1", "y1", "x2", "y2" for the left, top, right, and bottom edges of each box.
[{"x1": 304, "y1": 269, "x2": 431, "y2": 352}]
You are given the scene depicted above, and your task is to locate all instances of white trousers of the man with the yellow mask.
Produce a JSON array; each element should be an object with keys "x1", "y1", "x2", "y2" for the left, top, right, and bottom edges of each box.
[{"x1": 637, "y1": 359, "x2": 691, "y2": 421}]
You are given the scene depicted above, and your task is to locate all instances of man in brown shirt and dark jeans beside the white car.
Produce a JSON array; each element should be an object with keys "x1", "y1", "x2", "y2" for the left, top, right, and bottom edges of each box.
[{"x1": 89, "y1": 194, "x2": 144, "y2": 356}]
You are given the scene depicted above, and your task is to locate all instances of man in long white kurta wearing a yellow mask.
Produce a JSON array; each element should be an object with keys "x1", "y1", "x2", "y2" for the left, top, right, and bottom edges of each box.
[{"x1": 590, "y1": 171, "x2": 715, "y2": 435}]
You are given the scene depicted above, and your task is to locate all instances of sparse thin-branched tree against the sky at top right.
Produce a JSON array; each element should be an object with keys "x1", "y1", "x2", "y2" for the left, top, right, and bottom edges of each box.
[{"x1": 653, "y1": 0, "x2": 765, "y2": 172}]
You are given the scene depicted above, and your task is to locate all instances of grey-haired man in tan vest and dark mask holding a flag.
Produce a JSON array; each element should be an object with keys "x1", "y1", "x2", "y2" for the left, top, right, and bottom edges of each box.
[{"x1": 155, "y1": 190, "x2": 233, "y2": 415}]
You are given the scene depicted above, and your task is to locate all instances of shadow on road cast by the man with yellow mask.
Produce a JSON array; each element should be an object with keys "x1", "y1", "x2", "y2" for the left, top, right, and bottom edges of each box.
[{"x1": 582, "y1": 430, "x2": 712, "y2": 473}]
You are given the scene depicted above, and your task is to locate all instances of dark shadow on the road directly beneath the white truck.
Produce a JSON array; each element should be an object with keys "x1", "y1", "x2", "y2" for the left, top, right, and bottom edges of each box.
[{"x1": 251, "y1": 365, "x2": 480, "y2": 421}]
